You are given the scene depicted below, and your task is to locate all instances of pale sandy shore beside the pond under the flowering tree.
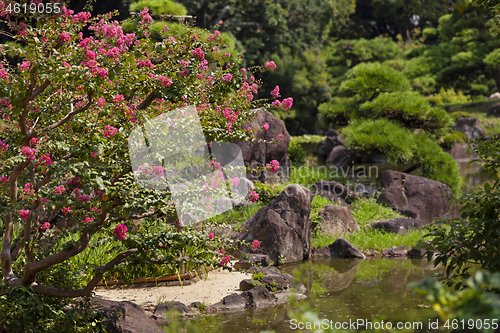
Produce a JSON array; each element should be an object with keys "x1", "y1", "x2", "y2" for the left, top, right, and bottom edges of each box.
[{"x1": 95, "y1": 264, "x2": 251, "y2": 308}]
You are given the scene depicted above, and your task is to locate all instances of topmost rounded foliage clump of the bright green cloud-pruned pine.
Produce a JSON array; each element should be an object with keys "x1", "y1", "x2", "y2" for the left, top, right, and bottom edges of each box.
[{"x1": 340, "y1": 63, "x2": 410, "y2": 101}]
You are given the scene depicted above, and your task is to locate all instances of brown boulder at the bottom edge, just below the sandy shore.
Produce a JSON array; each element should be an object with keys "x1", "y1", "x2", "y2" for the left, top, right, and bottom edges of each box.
[{"x1": 91, "y1": 297, "x2": 164, "y2": 333}]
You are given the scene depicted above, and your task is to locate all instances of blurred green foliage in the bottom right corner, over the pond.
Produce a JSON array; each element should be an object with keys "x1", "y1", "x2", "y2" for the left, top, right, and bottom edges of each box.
[{"x1": 410, "y1": 271, "x2": 500, "y2": 326}]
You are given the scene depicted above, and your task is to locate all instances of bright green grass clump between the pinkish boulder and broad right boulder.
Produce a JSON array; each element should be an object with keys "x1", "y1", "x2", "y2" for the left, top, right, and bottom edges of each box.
[{"x1": 351, "y1": 198, "x2": 402, "y2": 227}]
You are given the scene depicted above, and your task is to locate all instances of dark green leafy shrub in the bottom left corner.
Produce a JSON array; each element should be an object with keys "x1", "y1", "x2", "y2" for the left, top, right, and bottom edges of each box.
[{"x1": 0, "y1": 282, "x2": 106, "y2": 333}]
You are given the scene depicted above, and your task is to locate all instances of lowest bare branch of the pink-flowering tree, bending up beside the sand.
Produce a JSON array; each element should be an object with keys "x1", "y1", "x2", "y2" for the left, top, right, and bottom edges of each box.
[{"x1": 31, "y1": 249, "x2": 138, "y2": 297}]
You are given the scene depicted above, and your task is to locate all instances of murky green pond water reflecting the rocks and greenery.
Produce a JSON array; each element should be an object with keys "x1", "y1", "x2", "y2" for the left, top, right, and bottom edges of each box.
[{"x1": 165, "y1": 257, "x2": 449, "y2": 333}]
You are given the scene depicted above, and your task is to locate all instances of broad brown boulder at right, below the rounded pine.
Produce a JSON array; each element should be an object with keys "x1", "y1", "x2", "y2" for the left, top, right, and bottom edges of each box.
[{"x1": 377, "y1": 170, "x2": 459, "y2": 224}]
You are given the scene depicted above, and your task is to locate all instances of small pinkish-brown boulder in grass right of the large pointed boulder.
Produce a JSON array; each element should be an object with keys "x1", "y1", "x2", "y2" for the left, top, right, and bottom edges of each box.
[{"x1": 314, "y1": 205, "x2": 360, "y2": 236}]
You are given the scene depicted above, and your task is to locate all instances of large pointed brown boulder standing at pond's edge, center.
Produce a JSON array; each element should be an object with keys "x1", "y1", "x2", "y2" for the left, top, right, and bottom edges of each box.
[{"x1": 233, "y1": 184, "x2": 313, "y2": 265}]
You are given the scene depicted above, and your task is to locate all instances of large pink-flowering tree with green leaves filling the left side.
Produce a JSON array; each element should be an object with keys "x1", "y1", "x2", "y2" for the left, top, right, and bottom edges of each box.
[{"x1": 0, "y1": 1, "x2": 291, "y2": 297}]
